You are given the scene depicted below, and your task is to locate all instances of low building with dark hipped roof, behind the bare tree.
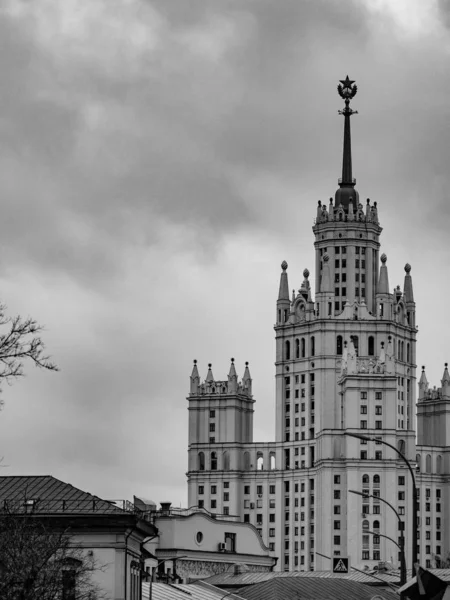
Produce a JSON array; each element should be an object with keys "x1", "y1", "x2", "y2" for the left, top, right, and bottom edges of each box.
[{"x1": 0, "y1": 475, "x2": 156, "y2": 600}]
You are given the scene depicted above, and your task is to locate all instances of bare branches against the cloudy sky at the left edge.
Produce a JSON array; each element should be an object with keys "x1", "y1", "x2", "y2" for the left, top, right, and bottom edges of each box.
[{"x1": 0, "y1": 304, "x2": 58, "y2": 403}]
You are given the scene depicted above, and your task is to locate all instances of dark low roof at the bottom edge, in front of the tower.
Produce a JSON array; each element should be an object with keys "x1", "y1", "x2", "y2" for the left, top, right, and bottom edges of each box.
[{"x1": 237, "y1": 577, "x2": 397, "y2": 600}]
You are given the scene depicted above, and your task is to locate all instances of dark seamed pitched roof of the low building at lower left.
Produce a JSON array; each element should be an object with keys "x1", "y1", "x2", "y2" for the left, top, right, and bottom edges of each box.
[{"x1": 0, "y1": 475, "x2": 125, "y2": 515}]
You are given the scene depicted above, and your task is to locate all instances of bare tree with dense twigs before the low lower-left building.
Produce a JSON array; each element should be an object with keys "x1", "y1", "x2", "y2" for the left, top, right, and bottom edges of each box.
[{"x1": 0, "y1": 503, "x2": 103, "y2": 600}]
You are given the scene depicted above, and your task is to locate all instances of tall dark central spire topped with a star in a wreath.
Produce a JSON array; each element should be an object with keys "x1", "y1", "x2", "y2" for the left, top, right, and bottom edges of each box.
[{"x1": 335, "y1": 75, "x2": 359, "y2": 209}]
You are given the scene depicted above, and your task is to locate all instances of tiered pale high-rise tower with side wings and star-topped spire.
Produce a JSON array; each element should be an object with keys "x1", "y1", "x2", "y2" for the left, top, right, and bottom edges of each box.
[{"x1": 188, "y1": 77, "x2": 450, "y2": 570}]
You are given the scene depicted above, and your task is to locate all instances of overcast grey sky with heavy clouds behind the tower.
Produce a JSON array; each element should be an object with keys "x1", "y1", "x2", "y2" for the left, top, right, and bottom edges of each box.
[{"x1": 0, "y1": 0, "x2": 450, "y2": 506}]
